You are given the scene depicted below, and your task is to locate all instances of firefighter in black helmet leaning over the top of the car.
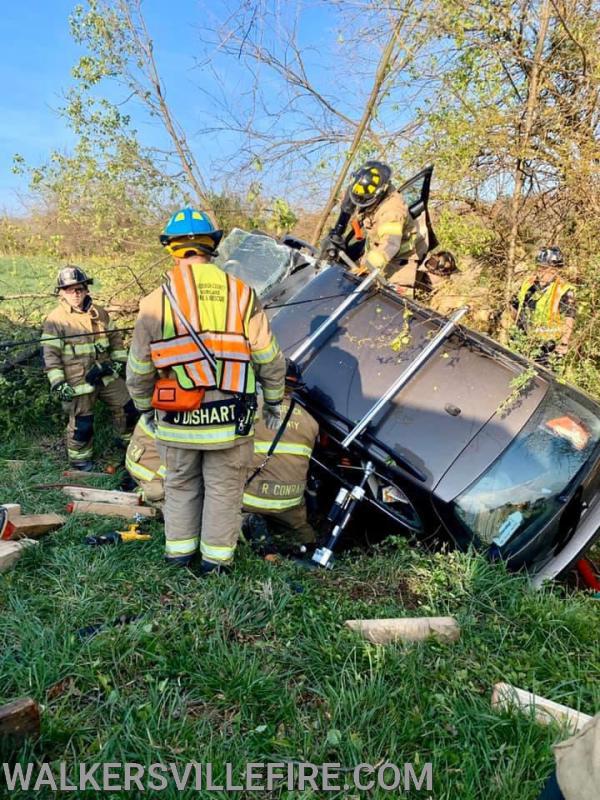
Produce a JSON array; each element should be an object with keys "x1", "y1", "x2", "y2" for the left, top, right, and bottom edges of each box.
[{"x1": 348, "y1": 161, "x2": 429, "y2": 298}]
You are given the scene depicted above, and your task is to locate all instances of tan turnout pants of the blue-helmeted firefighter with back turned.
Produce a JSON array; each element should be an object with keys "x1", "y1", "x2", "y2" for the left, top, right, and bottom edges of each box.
[{"x1": 157, "y1": 439, "x2": 254, "y2": 564}]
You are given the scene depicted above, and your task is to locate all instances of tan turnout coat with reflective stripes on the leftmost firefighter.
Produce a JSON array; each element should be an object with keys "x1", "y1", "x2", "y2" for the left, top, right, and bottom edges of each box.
[{"x1": 42, "y1": 298, "x2": 127, "y2": 395}]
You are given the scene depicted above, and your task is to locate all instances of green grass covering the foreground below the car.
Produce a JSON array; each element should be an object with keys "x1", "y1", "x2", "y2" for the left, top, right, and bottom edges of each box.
[{"x1": 0, "y1": 432, "x2": 600, "y2": 800}]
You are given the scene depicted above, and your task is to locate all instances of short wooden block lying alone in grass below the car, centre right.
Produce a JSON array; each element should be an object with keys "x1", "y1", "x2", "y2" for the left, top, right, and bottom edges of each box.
[{"x1": 346, "y1": 617, "x2": 460, "y2": 644}]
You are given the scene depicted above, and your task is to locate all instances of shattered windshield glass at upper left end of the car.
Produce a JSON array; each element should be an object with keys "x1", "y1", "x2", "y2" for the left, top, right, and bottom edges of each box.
[{"x1": 215, "y1": 228, "x2": 293, "y2": 297}]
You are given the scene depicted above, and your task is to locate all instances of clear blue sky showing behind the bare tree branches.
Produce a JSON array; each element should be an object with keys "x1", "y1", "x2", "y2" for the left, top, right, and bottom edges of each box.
[{"x1": 0, "y1": 0, "x2": 428, "y2": 214}]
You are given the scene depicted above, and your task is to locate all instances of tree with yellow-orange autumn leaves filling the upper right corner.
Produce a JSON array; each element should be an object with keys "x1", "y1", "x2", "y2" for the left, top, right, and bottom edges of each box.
[{"x1": 404, "y1": 0, "x2": 600, "y2": 306}]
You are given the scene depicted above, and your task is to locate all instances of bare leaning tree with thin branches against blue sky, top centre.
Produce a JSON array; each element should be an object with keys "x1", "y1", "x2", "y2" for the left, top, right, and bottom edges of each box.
[{"x1": 200, "y1": 0, "x2": 430, "y2": 220}]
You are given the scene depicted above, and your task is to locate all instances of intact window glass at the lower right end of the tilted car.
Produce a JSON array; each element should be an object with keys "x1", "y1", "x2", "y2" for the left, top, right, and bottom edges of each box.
[{"x1": 453, "y1": 392, "x2": 600, "y2": 547}]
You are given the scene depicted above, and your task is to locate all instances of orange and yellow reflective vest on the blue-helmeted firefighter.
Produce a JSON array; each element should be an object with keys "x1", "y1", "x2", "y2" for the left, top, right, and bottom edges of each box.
[{"x1": 151, "y1": 264, "x2": 256, "y2": 394}]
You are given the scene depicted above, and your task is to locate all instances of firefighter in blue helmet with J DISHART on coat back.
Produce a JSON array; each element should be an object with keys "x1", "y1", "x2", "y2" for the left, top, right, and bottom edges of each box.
[{"x1": 127, "y1": 208, "x2": 285, "y2": 574}]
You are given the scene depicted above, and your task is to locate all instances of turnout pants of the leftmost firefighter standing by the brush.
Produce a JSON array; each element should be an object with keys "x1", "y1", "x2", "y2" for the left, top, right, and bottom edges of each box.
[{"x1": 64, "y1": 378, "x2": 138, "y2": 463}]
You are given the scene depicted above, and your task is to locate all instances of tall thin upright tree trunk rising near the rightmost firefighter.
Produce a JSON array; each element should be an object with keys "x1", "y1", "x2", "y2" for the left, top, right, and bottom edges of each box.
[{"x1": 500, "y1": 0, "x2": 551, "y2": 343}]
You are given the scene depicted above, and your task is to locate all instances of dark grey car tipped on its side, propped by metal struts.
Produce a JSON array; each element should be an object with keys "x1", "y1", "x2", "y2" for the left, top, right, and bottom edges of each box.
[{"x1": 216, "y1": 206, "x2": 600, "y2": 584}]
